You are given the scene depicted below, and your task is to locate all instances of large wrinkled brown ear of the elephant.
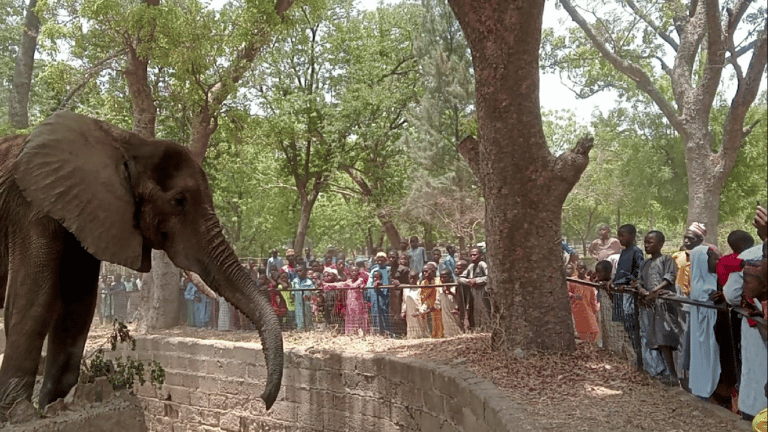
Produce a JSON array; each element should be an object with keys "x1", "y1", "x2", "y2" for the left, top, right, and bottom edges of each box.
[{"x1": 13, "y1": 111, "x2": 151, "y2": 271}]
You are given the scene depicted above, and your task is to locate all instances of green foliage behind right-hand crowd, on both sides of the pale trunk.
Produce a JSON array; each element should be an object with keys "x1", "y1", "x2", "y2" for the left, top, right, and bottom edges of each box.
[{"x1": 556, "y1": 94, "x2": 768, "y2": 250}]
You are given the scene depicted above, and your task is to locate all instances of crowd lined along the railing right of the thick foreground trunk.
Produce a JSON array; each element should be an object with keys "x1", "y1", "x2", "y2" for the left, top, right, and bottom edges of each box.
[{"x1": 566, "y1": 207, "x2": 768, "y2": 421}]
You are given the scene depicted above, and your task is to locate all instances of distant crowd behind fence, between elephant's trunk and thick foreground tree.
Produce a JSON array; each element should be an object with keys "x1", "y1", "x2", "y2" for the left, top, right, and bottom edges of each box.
[{"x1": 183, "y1": 236, "x2": 491, "y2": 338}]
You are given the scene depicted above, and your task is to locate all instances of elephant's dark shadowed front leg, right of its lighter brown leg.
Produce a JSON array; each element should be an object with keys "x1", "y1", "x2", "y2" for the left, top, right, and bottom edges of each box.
[{"x1": 39, "y1": 233, "x2": 101, "y2": 408}]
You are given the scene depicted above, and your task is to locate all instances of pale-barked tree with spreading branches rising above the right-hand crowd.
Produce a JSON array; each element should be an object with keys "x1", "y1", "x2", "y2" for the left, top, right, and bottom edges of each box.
[{"x1": 553, "y1": 0, "x2": 768, "y2": 243}]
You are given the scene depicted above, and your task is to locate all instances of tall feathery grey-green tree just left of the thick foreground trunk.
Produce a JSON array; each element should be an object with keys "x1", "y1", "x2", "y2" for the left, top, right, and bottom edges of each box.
[{"x1": 403, "y1": 0, "x2": 483, "y2": 250}]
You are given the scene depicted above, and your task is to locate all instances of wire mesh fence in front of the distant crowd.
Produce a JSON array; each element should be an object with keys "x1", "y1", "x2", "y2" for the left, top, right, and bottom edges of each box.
[{"x1": 181, "y1": 283, "x2": 480, "y2": 338}]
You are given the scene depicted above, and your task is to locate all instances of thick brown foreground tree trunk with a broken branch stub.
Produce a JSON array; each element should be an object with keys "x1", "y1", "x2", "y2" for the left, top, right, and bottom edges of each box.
[{"x1": 449, "y1": 0, "x2": 592, "y2": 350}]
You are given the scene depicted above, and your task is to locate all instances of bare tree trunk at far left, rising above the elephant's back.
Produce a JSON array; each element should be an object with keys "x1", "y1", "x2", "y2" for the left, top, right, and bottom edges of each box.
[{"x1": 8, "y1": 0, "x2": 40, "y2": 129}]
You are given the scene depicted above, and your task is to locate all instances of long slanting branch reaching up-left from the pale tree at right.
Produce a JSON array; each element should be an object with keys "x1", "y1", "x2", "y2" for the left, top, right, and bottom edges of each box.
[{"x1": 560, "y1": 0, "x2": 683, "y2": 131}]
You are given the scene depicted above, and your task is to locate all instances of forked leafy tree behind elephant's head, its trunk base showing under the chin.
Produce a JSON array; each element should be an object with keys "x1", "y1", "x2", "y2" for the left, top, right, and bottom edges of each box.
[{"x1": 37, "y1": 0, "x2": 293, "y2": 329}]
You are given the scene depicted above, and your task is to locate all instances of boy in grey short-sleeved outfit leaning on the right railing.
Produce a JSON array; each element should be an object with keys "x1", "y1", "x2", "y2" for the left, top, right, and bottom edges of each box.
[{"x1": 638, "y1": 231, "x2": 681, "y2": 386}]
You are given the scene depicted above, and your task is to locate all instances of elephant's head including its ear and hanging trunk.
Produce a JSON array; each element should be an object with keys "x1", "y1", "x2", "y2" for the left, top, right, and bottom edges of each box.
[{"x1": 13, "y1": 112, "x2": 283, "y2": 409}]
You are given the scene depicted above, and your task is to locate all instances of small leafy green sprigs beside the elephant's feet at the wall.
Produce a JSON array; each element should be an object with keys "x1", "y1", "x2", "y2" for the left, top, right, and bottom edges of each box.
[{"x1": 79, "y1": 321, "x2": 165, "y2": 391}]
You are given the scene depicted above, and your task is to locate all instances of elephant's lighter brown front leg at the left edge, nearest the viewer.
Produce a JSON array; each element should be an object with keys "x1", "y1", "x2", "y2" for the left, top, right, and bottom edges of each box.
[{"x1": 0, "y1": 218, "x2": 63, "y2": 421}]
